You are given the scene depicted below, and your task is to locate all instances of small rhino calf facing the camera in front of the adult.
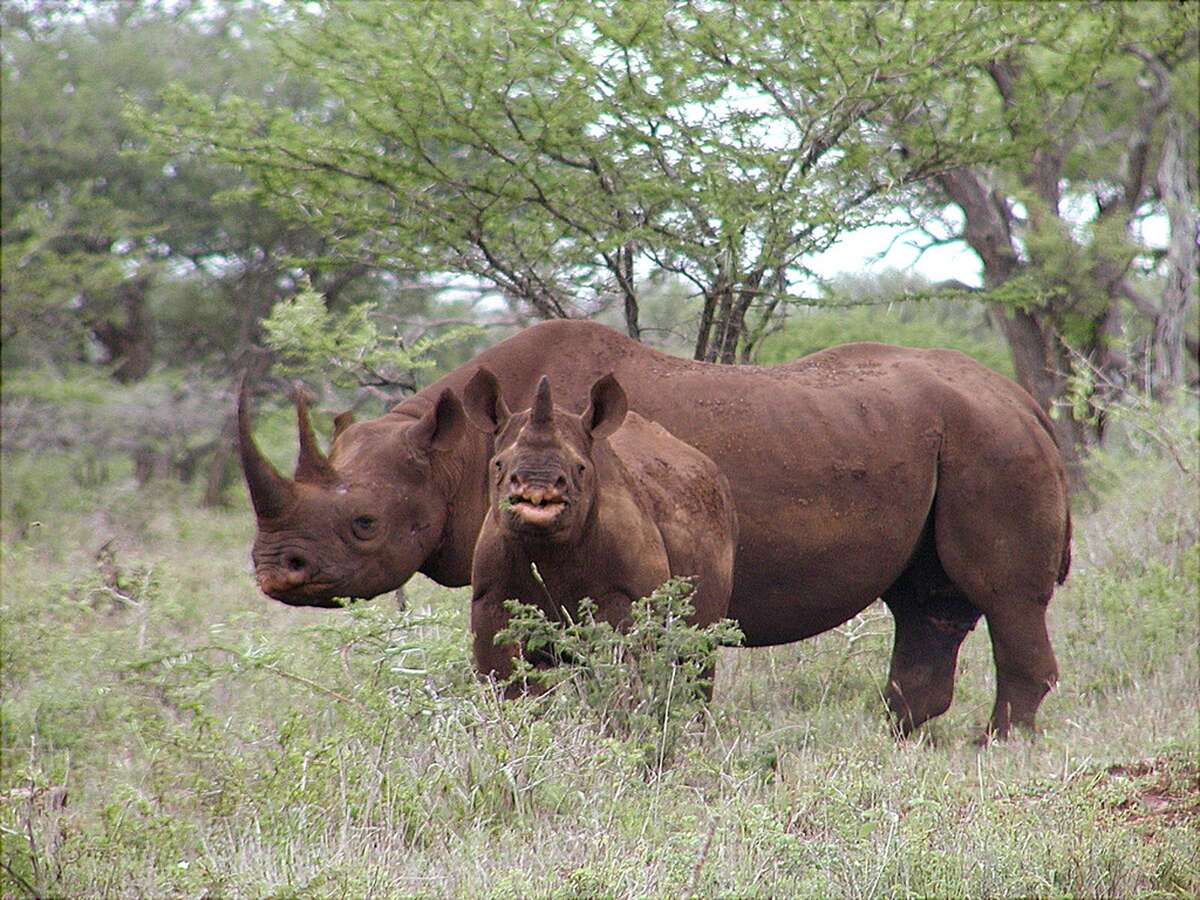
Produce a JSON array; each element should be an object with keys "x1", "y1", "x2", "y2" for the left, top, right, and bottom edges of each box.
[{"x1": 463, "y1": 368, "x2": 737, "y2": 694}]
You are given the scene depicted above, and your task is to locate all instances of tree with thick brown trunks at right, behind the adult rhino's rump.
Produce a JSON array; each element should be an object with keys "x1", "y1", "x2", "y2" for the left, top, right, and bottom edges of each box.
[{"x1": 876, "y1": 4, "x2": 1200, "y2": 472}]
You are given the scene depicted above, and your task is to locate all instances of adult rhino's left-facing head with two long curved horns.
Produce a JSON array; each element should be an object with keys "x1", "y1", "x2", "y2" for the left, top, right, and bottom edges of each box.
[{"x1": 238, "y1": 383, "x2": 466, "y2": 607}]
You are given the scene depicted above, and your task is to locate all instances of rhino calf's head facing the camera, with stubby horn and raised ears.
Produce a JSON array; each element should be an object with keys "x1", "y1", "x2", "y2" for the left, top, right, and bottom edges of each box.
[{"x1": 463, "y1": 368, "x2": 628, "y2": 544}]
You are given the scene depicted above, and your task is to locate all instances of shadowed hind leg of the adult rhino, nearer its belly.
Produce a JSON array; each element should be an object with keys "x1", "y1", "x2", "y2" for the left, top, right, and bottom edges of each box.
[{"x1": 883, "y1": 525, "x2": 980, "y2": 736}]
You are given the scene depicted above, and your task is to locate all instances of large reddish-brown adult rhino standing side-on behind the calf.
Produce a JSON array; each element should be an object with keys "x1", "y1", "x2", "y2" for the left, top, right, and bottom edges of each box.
[{"x1": 239, "y1": 320, "x2": 1070, "y2": 736}]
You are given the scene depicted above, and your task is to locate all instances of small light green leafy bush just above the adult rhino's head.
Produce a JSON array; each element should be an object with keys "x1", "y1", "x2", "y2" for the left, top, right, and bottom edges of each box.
[{"x1": 263, "y1": 286, "x2": 479, "y2": 386}]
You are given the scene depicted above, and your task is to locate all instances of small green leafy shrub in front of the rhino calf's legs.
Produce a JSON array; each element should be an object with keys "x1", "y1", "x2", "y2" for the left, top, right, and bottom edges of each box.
[{"x1": 496, "y1": 578, "x2": 742, "y2": 770}]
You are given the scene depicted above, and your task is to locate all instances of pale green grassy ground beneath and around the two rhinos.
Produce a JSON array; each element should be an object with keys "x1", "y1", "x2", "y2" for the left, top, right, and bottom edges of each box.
[{"x1": 0, "y1": 432, "x2": 1200, "y2": 898}]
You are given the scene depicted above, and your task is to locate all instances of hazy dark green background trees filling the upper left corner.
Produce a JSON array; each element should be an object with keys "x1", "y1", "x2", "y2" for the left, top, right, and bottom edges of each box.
[{"x1": 0, "y1": 0, "x2": 403, "y2": 382}]
